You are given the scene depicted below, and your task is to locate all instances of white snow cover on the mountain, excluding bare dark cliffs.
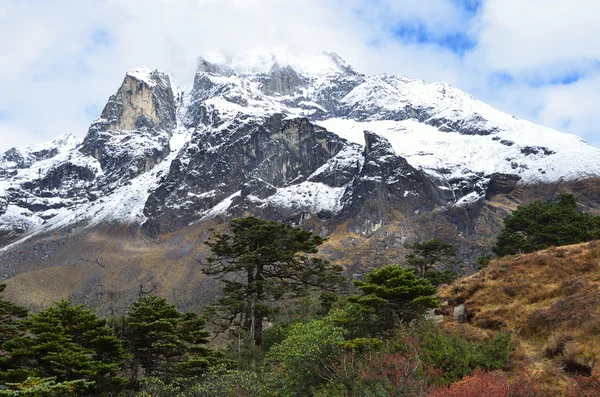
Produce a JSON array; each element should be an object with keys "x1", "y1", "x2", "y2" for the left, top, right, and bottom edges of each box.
[{"x1": 0, "y1": 49, "x2": 600, "y2": 246}]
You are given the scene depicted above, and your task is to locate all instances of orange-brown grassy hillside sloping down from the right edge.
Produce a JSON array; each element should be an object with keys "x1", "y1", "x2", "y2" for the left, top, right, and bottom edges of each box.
[{"x1": 440, "y1": 241, "x2": 600, "y2": 386}]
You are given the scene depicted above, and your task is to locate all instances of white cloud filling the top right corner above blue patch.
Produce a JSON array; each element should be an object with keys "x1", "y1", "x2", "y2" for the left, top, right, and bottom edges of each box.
[{"x1": 475, "y1": 0, "x2": 600, "y2": 73}]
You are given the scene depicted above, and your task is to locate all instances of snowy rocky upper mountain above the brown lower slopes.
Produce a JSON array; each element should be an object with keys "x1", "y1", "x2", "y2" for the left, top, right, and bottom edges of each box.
[{"x1": 0, "y1": 52, "x2": 600, "y2": 256}]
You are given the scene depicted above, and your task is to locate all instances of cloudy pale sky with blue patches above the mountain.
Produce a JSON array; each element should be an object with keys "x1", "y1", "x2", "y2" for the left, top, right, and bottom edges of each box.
[{"x1": 0, "y1": 0, "x2": 600, "y2": 152}]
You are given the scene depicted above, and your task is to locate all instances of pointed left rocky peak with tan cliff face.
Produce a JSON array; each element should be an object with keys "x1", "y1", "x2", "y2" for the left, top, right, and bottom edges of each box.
[{"x1": 80, "y1": 68, "x2": 177, "y2": 190}]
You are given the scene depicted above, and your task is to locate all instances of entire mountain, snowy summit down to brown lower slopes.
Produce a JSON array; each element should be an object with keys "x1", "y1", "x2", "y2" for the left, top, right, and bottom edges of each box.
[{"x1": 0, "y1": 53, "x2": 600, "y2": 313}]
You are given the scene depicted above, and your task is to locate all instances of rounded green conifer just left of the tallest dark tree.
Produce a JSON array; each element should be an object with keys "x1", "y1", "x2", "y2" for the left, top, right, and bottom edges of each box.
[{"x1": 125, "y1": 295, "x2": 216, "y2": 379}]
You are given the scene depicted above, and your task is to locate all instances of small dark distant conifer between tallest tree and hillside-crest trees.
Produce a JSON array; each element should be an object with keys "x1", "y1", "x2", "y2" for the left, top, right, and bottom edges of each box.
[{"x1": 406, "y1": 238, "x2": 457, "y2": 277}]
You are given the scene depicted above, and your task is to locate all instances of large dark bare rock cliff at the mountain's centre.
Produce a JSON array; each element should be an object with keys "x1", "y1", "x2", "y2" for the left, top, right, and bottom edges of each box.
[{"x1": 144, "y1": 114, "x2": 347, "y2": 235}]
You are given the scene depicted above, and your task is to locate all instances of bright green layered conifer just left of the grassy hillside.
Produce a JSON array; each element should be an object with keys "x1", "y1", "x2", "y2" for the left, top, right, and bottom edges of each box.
[{"x1": 347, "y1": 265, "x2": 441, "y2": 336}]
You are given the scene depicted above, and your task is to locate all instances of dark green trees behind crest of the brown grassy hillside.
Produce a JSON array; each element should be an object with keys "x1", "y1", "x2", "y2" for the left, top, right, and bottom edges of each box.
[{"x1": 493, "y1": 194, "x2": 600, "y2": 256}]
